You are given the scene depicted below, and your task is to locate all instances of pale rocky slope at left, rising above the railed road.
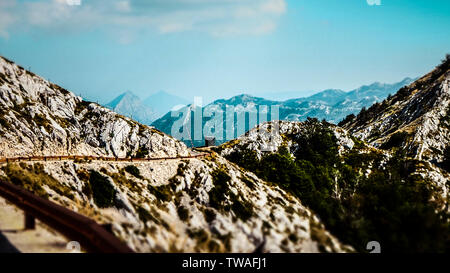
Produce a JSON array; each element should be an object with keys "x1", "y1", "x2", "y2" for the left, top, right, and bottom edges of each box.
[{"x1": 0, "y1": 57, "x2": 188, "y2": 157}]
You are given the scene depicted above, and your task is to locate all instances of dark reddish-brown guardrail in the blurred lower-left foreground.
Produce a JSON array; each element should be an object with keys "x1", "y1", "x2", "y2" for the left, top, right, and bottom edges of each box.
[{"x1": 0, "y1": 181, "x2": 133, "y2": 253}]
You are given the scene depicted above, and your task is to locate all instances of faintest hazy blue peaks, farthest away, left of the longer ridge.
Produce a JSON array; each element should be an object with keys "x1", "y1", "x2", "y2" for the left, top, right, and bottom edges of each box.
[{"x1": 105, "y1": 91, "x2": 189, "y2": 125}]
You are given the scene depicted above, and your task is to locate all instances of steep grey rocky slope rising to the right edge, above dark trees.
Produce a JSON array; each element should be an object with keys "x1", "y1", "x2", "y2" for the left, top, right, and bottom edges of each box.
[{"x1": 341, "y1": 56, "x2": 450, "y2": 161}]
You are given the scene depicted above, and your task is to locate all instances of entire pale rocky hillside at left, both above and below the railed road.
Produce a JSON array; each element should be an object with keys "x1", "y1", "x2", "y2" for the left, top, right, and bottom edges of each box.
[{"x1": 0, "y1": 55, "x2": 353, "y2": 252}]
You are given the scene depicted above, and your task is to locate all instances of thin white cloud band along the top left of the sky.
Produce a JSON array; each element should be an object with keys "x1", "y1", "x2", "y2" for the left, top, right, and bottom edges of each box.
[{"x1": 0, "y1": 0, "x2": 287, "y2": 37}]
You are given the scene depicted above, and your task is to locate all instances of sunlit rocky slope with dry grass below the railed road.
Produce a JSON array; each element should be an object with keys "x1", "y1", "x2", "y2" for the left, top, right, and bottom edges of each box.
[{"x1": 0, "y1": 155, "x2": 352, "y2": 252}]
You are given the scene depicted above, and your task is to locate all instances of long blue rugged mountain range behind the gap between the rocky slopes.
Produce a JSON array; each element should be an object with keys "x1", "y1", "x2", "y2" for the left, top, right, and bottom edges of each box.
[{"x1": 152, "y1": 78, "x2": 415, "y2": 146}]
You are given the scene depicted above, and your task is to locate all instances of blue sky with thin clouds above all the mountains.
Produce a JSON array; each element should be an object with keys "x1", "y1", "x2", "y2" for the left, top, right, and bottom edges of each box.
[{"x1": 0, "y1": 0, "x2": 450, "y2": 103}]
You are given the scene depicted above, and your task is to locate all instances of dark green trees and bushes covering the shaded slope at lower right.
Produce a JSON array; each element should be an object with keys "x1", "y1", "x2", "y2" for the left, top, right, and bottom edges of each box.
[{"x1": 223, "y1": 119, "x2": 450, "y2": 252}]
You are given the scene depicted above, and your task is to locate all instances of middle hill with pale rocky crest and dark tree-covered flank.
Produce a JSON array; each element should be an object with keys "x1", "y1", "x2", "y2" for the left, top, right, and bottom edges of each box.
[{"x1": 215, "y1": 116, "x2": 450, "y2": 252}]
